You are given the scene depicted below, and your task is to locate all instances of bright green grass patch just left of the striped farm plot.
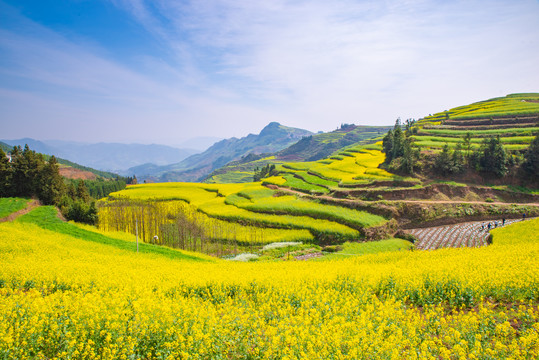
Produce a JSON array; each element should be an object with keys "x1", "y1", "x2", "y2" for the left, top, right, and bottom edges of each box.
[{"x1": 322, "y1": 238, "x2": 414, "y2": 259}]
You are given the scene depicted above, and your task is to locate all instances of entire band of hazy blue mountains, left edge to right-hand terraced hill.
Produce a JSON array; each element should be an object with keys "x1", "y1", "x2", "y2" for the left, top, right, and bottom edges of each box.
[{"x1": 3, "y1": 122, "x2": 396, "y2": 182}]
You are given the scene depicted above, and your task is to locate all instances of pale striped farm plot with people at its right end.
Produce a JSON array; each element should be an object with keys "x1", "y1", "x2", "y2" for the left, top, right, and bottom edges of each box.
[{"x1": 408, "y1": 220, "x2": 519, "y2": 250}]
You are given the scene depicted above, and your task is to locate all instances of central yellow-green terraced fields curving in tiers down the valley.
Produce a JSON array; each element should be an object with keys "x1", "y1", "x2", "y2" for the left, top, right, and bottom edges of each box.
[{"x1": 99, "y1": 180, "x2": 388, "y2": 251}]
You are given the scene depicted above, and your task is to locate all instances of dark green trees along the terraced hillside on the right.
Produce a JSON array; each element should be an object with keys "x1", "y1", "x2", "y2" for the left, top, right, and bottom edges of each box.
[{"x1": 382, "y1": 119, "x2": 539, "y2": 181}]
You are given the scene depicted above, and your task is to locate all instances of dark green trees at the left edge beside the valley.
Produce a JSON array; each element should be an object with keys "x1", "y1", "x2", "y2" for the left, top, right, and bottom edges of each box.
[{"x1": 0, "y1": 145, "x2": 130, "y2": 224}]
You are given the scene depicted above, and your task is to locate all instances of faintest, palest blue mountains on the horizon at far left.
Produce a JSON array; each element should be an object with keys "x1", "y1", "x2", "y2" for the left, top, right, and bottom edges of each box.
[{"x1": 2, "y1": 138, "x2": 199, "y2": 175}]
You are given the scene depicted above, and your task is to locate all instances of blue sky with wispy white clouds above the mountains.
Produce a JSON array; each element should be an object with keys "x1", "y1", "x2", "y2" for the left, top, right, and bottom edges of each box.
[{"x1": 0, "y1": 0, "x2": 539, "y2": 145}]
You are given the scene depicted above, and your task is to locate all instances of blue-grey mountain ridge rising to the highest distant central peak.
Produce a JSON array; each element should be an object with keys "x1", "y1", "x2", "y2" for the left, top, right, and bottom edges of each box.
[{"x1": 131, "y1": 122, "x2": 312, "y2": 181}]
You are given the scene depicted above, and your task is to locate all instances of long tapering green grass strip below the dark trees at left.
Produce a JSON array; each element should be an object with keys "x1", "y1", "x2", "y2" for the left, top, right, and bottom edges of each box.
[{"x1": 16, "y1": 206, "x2": 212, "y2": 261}]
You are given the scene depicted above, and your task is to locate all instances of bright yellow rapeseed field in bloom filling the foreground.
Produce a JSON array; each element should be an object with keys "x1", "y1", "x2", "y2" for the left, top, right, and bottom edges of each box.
[{"x1": 0, "y1": 211, "x2": 539, "y2": 359}]
